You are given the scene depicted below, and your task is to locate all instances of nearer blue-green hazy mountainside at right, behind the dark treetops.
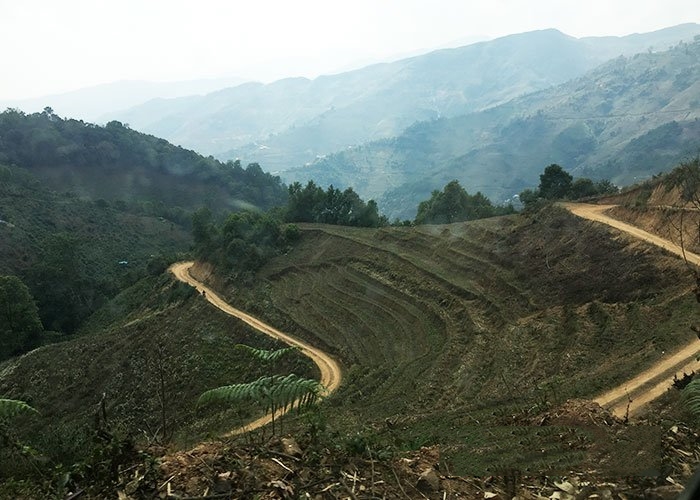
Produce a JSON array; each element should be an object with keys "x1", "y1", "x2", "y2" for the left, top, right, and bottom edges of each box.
[{"x1": 284, "y1": 36, "x2": 700, "y2": 218}]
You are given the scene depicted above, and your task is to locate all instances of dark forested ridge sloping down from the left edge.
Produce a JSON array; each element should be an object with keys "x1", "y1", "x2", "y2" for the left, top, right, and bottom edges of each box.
[{"x1": 0, "y1": 108, "x2": 286, "y2": 211}]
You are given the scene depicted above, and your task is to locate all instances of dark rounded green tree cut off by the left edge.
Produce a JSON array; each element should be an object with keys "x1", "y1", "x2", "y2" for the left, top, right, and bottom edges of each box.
[{"x1": 0, "y1": 276, "x2": 44, "y2": 360}]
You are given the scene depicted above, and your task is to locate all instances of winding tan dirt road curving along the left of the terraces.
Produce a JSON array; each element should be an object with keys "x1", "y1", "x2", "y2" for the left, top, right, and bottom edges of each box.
[{"x1": 170, "y1": 262, "x2": 342, "y2": 436}]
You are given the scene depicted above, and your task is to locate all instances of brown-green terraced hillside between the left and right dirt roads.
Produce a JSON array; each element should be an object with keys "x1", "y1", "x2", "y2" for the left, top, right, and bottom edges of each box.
[{"x1": 212, "y1": 209, "x2": 696, "y2": 472}]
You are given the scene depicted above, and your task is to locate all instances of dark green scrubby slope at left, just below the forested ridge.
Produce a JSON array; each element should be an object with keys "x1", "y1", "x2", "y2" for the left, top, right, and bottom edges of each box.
[{"x1": 0, "y1": 165, "x2": 191, "y2": 334}]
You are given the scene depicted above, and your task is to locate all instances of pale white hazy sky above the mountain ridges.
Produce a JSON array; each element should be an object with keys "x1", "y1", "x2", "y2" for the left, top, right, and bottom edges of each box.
[{"x1": 0, "y1": 0, "x2": 700, "y2": 99}]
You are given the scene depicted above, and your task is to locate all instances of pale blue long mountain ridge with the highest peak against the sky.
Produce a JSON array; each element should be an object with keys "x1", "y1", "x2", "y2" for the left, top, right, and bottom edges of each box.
[{"x1": 112, "y1": 24, "x2": 700, "y2": 172}]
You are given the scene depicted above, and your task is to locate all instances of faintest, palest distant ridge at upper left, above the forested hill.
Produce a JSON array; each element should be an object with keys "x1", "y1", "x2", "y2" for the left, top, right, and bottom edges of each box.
[{"x1": 0, "y1": 78, "x2": 245, "y2": 122}]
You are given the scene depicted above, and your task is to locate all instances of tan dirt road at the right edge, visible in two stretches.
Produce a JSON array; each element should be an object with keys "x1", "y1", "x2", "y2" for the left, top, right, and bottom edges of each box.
[{"x1": 561, "y1": 203, "x2": 700, "y2": 417}]
